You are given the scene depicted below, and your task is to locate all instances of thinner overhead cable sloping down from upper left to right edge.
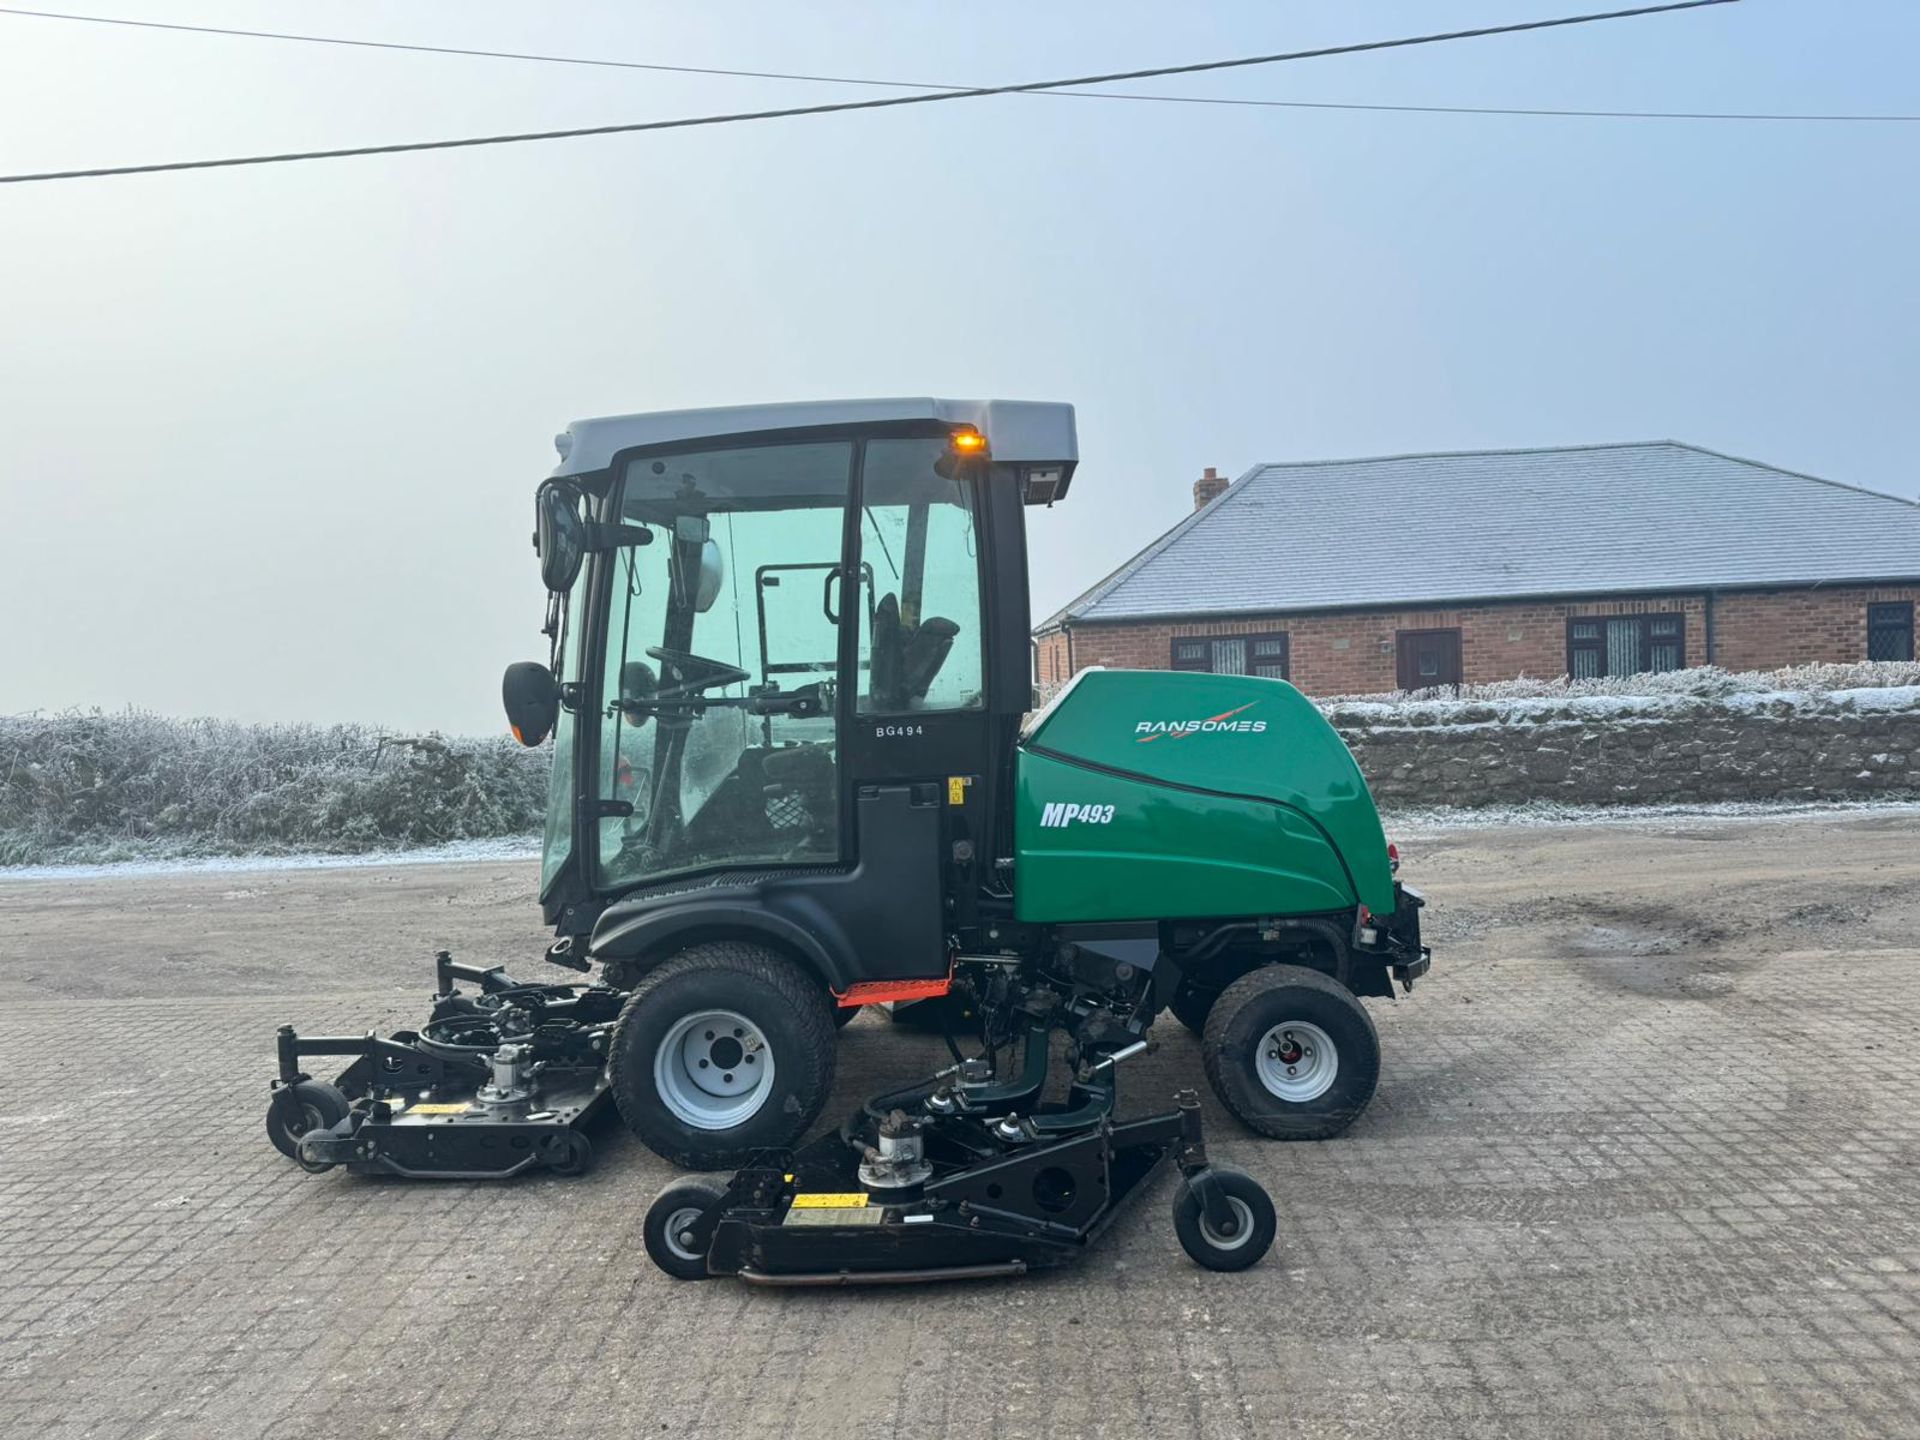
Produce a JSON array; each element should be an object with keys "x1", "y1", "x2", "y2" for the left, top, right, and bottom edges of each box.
[{"x1": 0, "y1": 6, "x2": 1920, "y2": 125}]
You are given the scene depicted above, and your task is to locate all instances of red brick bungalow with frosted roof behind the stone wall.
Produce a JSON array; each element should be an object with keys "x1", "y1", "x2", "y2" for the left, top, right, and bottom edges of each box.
[{"x1": 1035, "y1": 442, "x2": 1920, "y2": 695}]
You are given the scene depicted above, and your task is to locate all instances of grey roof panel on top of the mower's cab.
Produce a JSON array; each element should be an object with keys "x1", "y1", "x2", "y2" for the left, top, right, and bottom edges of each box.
[{"x1": 553, "y1": 397, "x2": 1079, "y2": 476}]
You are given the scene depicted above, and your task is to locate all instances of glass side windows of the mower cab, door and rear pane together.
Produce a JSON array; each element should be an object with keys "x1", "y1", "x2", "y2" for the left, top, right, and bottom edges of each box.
[{"x1": 579, "y1": 430, "x2": 990, "y2": 895}]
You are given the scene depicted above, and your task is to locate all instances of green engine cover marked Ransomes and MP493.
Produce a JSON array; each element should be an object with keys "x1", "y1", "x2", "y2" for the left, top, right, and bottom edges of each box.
[{"x1": 1014, "y1": 670, "x2": 1394, "y2": 922}]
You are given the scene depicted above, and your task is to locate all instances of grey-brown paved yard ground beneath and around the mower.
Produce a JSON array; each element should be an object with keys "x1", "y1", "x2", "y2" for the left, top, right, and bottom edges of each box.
[{"x1": 0, "y1": 816, "x2": 1920, "y2": 1440}]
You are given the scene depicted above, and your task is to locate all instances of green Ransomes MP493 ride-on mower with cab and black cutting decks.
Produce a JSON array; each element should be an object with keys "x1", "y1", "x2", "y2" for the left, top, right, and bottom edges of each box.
[{"x1": 267, "y1": 399, "x2": 1428, "y2": 1284}]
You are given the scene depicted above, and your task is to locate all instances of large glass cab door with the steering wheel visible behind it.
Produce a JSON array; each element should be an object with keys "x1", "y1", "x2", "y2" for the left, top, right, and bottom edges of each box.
[{"x1": 591, "y1": 438, "x2": 858, "y2": 893}]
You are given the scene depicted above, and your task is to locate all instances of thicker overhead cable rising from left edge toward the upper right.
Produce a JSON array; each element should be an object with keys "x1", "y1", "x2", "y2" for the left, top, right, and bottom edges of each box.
[{"x1": 0, "y1": 0, "x2": 1740, "y2": 184}]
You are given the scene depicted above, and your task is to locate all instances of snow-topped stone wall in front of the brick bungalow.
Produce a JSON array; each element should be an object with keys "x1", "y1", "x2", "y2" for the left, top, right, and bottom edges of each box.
[{"x1": 1327, "y1": 687, "x2": 1920, "y2": 808}]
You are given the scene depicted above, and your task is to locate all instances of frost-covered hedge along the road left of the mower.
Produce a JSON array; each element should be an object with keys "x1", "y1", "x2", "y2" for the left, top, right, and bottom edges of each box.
[{"x1": 0, "y1": 710, "x2": 547, "y2": 866}]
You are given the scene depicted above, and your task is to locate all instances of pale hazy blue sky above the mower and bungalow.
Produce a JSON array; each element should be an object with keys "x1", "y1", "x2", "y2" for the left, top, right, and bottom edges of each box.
[{"x1": 0, "y1": 0, "x2": 1920, "y2": 732}]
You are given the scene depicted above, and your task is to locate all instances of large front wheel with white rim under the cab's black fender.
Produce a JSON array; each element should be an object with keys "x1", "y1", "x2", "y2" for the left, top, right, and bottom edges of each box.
[{"x1": 607, "y1": 941, "x2": 835, "y2": 1169}]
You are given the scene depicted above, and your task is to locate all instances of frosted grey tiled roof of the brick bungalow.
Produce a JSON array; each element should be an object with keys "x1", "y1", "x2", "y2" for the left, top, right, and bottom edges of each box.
[{"x1": 1041, "y1": 440, "x2": 1920, "y2": 630}]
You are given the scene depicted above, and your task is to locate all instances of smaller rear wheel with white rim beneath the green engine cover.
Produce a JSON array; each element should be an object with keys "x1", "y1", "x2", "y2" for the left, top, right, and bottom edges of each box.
[{"x1": 1200, "y1": 966, "x2": 1380, "y2": 1140}]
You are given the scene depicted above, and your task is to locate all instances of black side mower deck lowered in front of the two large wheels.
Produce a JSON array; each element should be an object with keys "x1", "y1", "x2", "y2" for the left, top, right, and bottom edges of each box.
[{"x1": 645, "y1": 1027, "x2": 1275, "y2": 1286}]
